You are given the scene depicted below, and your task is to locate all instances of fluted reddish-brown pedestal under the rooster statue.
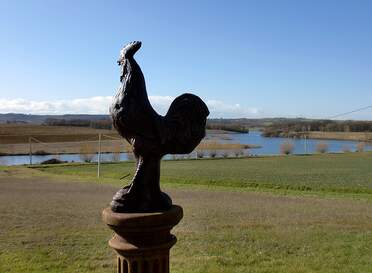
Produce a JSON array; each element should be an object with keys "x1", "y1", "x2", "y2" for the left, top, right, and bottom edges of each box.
[{"x1": 102, "y1": 205, "x2": 183, "y2": 273}]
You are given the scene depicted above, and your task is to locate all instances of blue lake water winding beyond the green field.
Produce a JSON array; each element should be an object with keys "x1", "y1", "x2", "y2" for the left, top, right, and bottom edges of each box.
[{"x1": 0, "y1": 131, "x2": 372, "y2": 166}]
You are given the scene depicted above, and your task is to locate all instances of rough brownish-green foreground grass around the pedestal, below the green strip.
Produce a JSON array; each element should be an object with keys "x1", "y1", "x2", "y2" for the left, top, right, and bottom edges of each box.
[{"x1": 0, "y1": 170, "x2": 372, "y2": 273}]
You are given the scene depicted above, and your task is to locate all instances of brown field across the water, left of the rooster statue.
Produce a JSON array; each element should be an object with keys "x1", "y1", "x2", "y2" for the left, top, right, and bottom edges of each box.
[{"x1": 0, "y1": 124, "x2": 129, "y2": 155}]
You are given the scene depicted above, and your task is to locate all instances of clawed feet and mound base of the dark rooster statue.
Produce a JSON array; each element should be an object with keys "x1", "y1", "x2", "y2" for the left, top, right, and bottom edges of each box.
[{"x1": 110, "y1": 185, "x2": 172, "y2": 213}]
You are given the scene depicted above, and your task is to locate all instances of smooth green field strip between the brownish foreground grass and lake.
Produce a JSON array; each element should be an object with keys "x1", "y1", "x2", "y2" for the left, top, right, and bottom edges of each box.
[{"x1": 35, "y1": 153, "x2": 372, "y2": 194}]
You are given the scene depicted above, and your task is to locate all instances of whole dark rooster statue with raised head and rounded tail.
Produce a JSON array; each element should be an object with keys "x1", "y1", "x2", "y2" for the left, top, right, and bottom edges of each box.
[{"x1": 110, "y1": 41, "x2": 209, "y2": 212}]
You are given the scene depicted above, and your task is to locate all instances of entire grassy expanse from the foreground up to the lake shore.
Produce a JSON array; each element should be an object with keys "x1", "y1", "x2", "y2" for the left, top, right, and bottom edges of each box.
[{"x1": 0, "y1": 153, "x2": 372, "y2": 273}]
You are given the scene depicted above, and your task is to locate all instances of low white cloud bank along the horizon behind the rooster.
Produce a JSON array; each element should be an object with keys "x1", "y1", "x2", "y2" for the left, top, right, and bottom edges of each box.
[{"x1": 0, "y1": 96, "x2": 259, "y2": 118}]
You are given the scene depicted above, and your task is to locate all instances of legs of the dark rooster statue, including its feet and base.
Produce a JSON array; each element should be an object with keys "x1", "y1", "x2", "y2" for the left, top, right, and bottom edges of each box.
[{"x1": 111, "y1": 156, "x2": 172, "y2": 212}]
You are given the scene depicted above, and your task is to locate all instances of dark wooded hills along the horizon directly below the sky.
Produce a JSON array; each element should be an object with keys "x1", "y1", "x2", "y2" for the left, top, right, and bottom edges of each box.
[{"x1": 0, "y1": 113, "x2": 372, "y2": 133}]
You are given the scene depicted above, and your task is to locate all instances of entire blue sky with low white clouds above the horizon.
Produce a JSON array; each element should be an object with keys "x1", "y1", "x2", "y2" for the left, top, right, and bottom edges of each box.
[{"x1": 0, "y1": 0, "x2": 372, "y2": 119}]
